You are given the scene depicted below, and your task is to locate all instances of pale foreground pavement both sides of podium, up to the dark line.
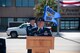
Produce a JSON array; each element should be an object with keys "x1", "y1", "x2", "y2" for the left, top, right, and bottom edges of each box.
[{"x1": 6, "y1": 37, "x2": 80, "y2": 53}]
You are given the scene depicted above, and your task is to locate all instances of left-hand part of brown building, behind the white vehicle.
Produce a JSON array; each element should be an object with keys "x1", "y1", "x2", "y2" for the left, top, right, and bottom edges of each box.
[{"x1": 0, "y1": 0, "x2": 38, "y2": 30}]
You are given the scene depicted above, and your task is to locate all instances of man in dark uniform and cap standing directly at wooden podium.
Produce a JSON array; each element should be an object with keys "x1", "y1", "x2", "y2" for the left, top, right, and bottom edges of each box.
[{"x1": 30, "y1": 18, "x2": 52, "y2": 36}]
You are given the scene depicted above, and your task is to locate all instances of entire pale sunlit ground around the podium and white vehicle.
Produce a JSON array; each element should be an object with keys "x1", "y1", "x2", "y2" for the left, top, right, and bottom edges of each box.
[{"x1": 0, "y1": 32, "x2": 80, "y2": 53}]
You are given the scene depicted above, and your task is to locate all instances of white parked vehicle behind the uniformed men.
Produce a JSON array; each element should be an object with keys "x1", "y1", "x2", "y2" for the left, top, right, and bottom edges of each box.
[{"x1": 6, "y1": 23, "x2": 30, "y2": 38}]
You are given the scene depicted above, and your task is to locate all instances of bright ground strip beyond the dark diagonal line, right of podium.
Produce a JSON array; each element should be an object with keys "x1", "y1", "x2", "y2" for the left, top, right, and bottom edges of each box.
[{"x1": 53, "y1": 32, "x2": 80, "y2": 42}]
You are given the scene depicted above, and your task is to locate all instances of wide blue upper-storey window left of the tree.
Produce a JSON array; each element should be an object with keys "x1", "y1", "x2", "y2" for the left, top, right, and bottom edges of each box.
[{"x1": 16, "y1": 0, "x2": 35, "y2": 7}]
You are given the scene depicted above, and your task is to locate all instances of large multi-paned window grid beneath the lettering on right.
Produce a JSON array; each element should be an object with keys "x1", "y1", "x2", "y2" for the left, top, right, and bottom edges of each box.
[{"x1": 61, "y1": 18, "x2": 79, "y2": 30}]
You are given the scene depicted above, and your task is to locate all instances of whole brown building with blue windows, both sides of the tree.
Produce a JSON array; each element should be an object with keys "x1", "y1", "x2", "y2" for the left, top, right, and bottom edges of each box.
[{"x1": 0, "y1": 0, "x2": 80, "y2": 31}]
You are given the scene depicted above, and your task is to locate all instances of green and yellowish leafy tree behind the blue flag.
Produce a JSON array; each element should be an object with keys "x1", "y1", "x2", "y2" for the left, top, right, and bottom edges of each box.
[{"x1": 34, "y1": 0, "x2": 57, "y2": 18}]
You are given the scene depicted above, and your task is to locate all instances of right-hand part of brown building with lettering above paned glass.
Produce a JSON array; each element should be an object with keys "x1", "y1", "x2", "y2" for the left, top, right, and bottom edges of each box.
[{"x1": 60, "y1": 6, "x2": 80, "y2": 31}]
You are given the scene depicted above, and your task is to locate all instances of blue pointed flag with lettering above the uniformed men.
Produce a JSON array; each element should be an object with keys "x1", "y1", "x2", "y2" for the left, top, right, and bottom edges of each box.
[{"x1": 43, "y1": 6, "x2": 61, "y2": 25}]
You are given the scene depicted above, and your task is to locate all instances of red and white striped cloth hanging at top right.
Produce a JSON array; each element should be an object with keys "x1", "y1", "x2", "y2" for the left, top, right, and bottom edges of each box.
[{"x1": 60, "y1": 0, "x2": 80, "y2": 7}]
